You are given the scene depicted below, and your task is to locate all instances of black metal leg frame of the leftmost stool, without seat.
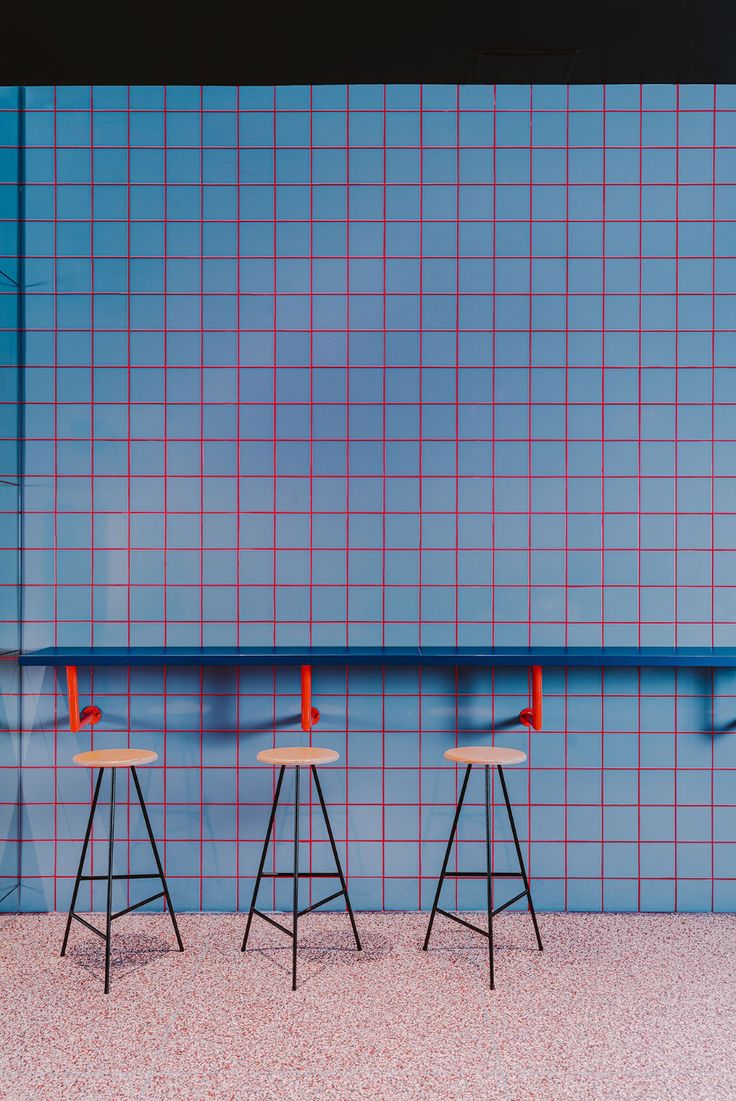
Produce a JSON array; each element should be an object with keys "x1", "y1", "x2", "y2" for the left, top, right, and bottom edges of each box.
[{"x1": 61, "y1": 767, "x2": 184, "y2": 994}]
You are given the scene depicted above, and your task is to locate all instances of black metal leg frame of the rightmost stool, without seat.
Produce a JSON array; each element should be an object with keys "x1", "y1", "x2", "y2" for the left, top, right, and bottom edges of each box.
[{"x1": 422, "y1": 764, "x2": 542, "y2": 990}]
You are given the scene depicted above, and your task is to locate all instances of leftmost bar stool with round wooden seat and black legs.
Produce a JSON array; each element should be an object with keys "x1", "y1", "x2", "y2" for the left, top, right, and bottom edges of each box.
[{"x1": 62, "y1": 749, "x2": 184, "y2": 994}]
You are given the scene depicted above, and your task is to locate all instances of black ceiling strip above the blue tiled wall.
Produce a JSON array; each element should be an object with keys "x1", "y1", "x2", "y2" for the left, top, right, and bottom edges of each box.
[{"x1": 0, "y1": 0, "x2": 736, "y2": 85}]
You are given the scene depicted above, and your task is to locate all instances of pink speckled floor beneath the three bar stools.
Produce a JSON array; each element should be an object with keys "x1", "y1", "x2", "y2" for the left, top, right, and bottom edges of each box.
[{"x1": 0, "y1": 913, "x2": 736, "y2": 1101}]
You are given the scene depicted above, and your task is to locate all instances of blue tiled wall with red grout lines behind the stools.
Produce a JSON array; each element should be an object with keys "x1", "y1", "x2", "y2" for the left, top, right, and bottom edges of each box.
[{"x1": 3, "y1": 86, "x2": 736, "y2": 909}]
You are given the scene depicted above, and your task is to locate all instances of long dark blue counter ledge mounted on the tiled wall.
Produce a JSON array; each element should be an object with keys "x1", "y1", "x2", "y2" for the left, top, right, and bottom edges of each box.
[{"x1": 19, "y1": 646, "x2": 736, "y2": 668}]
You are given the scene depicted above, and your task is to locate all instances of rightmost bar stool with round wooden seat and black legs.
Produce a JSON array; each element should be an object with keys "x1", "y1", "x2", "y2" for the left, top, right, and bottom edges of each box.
[{"x1": 422, "y1": 745, "x2": 542, "y2": 990}]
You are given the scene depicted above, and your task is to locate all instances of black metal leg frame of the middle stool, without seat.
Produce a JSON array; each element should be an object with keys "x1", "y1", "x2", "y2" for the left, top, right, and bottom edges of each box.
[{"x1": 240, "y1": 765, "x2": 361, "y2": 990}]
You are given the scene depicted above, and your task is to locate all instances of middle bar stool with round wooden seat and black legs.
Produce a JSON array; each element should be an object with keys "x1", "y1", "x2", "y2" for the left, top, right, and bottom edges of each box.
[{"x1": 240, "y1": 746, "x2": 360, "y2": 990}]
